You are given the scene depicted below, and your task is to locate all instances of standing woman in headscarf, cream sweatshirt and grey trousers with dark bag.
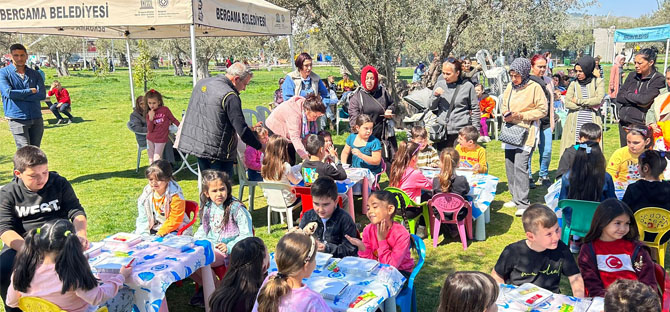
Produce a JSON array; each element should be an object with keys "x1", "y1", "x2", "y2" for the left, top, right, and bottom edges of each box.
[{"x1": 501, "y1": 58, "x2": 547, "y2": 216}]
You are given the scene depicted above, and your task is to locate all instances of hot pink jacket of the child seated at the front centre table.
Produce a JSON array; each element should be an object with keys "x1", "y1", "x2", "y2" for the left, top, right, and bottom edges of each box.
[{"x1": 358, "y1": 221, "x2": 414, "y2": 272}]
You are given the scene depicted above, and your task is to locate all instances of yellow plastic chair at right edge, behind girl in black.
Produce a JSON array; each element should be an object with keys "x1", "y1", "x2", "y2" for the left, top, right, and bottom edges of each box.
[{"x1": 635, "y1": 207, "x2": 670, "y2": 267}]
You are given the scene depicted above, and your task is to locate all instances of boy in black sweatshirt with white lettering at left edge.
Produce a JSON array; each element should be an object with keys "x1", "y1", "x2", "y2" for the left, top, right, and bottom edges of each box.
[{"x1": 0, "y1": 145, "x2": 88, "y2": 312}]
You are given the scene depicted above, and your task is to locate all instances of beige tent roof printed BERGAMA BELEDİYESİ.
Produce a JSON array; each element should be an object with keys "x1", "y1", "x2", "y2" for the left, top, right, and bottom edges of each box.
[{"x1": 0, "y1": 0, "x2": 291, "y2": 39}]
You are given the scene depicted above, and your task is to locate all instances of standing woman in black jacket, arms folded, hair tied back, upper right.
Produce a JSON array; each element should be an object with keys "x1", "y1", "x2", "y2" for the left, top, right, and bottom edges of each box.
[{"x1": 616, "y1": 47, "x2": 665, "y2": 147}]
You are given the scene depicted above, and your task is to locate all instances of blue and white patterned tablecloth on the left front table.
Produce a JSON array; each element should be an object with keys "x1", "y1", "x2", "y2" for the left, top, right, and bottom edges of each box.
[{"x1": 89, "y1": 236, "x2": 214, "y2": 312}]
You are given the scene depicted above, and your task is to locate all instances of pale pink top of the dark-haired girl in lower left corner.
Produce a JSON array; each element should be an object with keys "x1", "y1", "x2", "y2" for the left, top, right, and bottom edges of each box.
[{"x1": 7, "y1": 264, "x2": 124, "y2": 312}]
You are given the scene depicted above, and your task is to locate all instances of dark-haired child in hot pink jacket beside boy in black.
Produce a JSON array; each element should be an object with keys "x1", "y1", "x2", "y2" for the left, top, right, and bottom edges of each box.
[{"x1": 345, "y1": 191, "x2": 414, "y2": 277}]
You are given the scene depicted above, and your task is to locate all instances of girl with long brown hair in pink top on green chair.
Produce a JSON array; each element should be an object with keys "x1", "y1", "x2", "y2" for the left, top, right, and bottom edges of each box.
[{"x1": 389, "y1": 142, "x2": 433, "y2": 203}]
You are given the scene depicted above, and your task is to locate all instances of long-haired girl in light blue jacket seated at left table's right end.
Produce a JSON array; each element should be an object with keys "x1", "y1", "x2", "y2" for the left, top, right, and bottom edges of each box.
[{"x1": 191, "y1": 170, "x2": 253, "y2": 305}]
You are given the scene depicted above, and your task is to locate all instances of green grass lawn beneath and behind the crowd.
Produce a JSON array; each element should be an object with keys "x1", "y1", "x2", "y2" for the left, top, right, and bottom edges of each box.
[{"x1": 0, "y1": 67, "x2": 664, "y2": 311}]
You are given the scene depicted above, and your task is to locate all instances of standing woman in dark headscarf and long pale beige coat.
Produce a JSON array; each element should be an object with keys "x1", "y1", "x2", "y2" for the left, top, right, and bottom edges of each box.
[{"x1": 559, "y1": 55, "x2": 605, "y2": 155}]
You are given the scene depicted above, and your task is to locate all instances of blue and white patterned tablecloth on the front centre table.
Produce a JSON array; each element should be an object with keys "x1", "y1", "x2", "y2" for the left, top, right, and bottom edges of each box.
[{"x1": 268, "y1": 252, "x2": 407, "y2": 312}]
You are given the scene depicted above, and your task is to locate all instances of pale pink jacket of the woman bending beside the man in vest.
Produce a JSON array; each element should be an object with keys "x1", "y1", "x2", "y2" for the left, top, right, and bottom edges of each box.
[{"x1": 265, "y1": 96, "x2": 309, "y2": 159}]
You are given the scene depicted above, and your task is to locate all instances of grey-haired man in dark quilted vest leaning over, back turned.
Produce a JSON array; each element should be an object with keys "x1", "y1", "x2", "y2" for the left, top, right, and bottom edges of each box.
[{"x1": 177, "y1": 62, "x2": 262, "y2": 177}]
